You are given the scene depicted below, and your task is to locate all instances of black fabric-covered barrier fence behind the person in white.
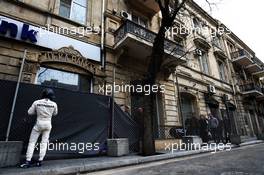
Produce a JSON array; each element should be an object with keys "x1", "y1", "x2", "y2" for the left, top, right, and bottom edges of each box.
[{"x1": 0, "y1": 80, "x2": 138, "y2": 157}]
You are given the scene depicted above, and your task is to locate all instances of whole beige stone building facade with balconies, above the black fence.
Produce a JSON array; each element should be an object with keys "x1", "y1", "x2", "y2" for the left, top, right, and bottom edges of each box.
[{"x1": 0, "y1": 0, "x2": 264, "y2": 148}]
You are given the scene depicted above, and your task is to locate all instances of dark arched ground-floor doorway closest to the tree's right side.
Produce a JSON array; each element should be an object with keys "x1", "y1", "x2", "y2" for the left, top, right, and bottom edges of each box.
[{"x1": 180, "y1": 92, "x2": 199, "y2": 135}]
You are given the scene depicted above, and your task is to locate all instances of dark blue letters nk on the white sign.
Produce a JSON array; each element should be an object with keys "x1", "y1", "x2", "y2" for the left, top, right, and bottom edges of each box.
[{"x1": 0, "y1": 20, "x2": 38, "y2": 43}]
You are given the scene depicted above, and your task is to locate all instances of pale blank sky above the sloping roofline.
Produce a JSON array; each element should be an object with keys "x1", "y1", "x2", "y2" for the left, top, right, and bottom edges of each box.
[{"x1": 195, "y1": 0, "x2": 264, "y2": 62}]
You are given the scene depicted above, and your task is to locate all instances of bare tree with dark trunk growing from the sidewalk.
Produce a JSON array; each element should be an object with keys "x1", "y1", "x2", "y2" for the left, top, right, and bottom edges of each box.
[{"x1": 142, "y1": 0, "x2": 212, "y2": 156}]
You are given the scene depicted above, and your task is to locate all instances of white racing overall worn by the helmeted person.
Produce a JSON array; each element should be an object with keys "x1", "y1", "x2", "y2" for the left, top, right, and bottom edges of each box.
[{"x1": 26, "y1": 98, "x2": 58, "y2": 161}]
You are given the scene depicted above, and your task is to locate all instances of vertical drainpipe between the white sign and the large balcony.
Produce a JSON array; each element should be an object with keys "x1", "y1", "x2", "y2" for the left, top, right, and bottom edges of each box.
[{"x1": 101, "y1": 0, "x2": 105, "y2": 68}]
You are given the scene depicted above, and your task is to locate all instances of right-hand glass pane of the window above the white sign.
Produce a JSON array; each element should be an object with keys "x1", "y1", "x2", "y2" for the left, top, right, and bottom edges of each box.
[{"x1": 71, "y1": 3, "x2": 86, "y2": 24}]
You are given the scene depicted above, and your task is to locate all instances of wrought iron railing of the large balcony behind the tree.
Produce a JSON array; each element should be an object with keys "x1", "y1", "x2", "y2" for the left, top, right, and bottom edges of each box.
[{"x1": 115, "y1": 20, "x2": 185, "y2": 56}]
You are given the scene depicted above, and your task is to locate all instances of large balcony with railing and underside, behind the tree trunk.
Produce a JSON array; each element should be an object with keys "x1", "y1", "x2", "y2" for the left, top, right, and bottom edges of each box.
[{"x1": 114, "y1": 20, "x2": 186, "y2": 66}]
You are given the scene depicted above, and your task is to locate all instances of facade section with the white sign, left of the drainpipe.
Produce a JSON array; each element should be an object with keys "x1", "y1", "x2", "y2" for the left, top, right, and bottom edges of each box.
[{"x1": 0, "y1": 1, "x2": 103, "y2": 92}]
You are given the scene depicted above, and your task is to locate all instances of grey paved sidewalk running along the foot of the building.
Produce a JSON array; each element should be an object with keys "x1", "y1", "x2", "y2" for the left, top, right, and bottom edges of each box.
[{"x1": 0, "y1": 140, "x2": 264, "y2": 175}]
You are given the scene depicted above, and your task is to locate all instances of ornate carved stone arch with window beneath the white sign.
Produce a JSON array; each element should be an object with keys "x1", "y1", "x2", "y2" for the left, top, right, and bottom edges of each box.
[{"x1": 24, "y1": 46, "x2": 104, "y2": 93}]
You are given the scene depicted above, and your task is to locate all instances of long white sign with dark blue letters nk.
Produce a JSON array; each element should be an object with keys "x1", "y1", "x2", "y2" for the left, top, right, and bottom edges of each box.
[{"x1": 0, "y1": 15, "x2": 101, "y2": 61}]
